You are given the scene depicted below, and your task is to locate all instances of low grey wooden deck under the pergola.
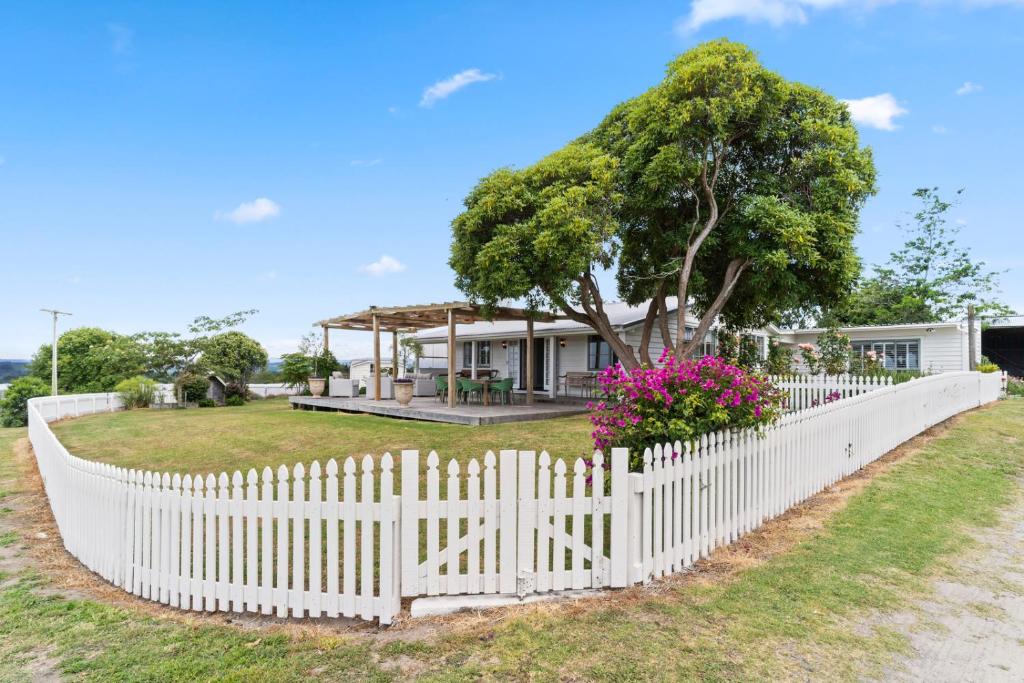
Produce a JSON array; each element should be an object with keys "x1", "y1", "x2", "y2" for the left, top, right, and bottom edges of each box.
[{"x1": 289, "y1": 396, "x2": 587, "y2": 425}]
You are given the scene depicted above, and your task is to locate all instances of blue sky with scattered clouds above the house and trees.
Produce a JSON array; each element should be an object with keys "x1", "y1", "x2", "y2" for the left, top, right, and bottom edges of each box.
[{"x1": 0, "y1": 0, "x2": 1024, "y2": 357}]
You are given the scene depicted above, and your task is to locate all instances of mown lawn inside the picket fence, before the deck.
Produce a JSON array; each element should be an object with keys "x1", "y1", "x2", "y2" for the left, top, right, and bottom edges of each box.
[{"x1": 53, "y1": 398, "x2": 593, "y2": 473}]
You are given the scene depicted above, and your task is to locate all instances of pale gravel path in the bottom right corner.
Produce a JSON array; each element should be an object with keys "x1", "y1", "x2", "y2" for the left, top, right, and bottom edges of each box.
[{"x1": 872, "y1": 484, "x2": 1024, "y2": 682}]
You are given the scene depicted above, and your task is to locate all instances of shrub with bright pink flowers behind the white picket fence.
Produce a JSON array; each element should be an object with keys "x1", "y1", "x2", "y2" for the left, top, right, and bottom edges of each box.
[{"x1": 587, "y1": 352, "x2": 781, "y2": 470}]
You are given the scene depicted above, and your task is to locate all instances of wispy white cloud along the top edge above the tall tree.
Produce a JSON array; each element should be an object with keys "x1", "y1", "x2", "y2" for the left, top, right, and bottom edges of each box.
[{"x1": 676, "y1": 0, "x2": 1024, "y2": 35}]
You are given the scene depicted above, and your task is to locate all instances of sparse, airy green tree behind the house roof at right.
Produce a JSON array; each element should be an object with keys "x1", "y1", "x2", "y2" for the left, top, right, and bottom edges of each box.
[{"x1": 826, "y1": 187, "x2": 1014, "y2": 325}]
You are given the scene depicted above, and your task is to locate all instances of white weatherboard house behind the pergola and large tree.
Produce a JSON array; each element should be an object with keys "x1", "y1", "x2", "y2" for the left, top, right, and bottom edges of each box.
[{"x1": 416, "y1": 299, "x2": 980, "y2": 398}]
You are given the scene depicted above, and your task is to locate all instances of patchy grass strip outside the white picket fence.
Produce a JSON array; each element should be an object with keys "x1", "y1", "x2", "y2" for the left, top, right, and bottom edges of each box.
[{"x1": 0, "y1": 401, "x2": 1024, "y2": 681}]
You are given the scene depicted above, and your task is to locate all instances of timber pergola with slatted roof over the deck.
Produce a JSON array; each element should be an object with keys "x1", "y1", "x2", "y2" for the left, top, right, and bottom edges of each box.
[{"x1": 315, "y1": 301, "x2": 558, "y2": 408}]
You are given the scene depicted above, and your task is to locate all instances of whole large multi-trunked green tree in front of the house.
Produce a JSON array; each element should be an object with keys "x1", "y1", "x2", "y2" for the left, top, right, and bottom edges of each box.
[{"x1": 451, "y1": 40, "x2": 874, "y2": 367}]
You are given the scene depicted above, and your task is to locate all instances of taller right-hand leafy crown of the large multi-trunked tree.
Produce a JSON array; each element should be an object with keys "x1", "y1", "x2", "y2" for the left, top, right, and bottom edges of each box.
[{"x1": 590, "y1": 40, "x2": 874, "y2": 354}]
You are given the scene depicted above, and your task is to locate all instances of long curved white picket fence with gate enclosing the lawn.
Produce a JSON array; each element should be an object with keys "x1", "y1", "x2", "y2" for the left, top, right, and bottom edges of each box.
[{"x1": 29, "y1": 372, "x2": 1002, "y2": 624}]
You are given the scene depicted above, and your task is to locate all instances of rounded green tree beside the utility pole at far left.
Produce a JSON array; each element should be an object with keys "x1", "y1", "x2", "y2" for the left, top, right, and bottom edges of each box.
[{"x1": 32, "y1": 328, "x2": 146, "y2": 393}]
